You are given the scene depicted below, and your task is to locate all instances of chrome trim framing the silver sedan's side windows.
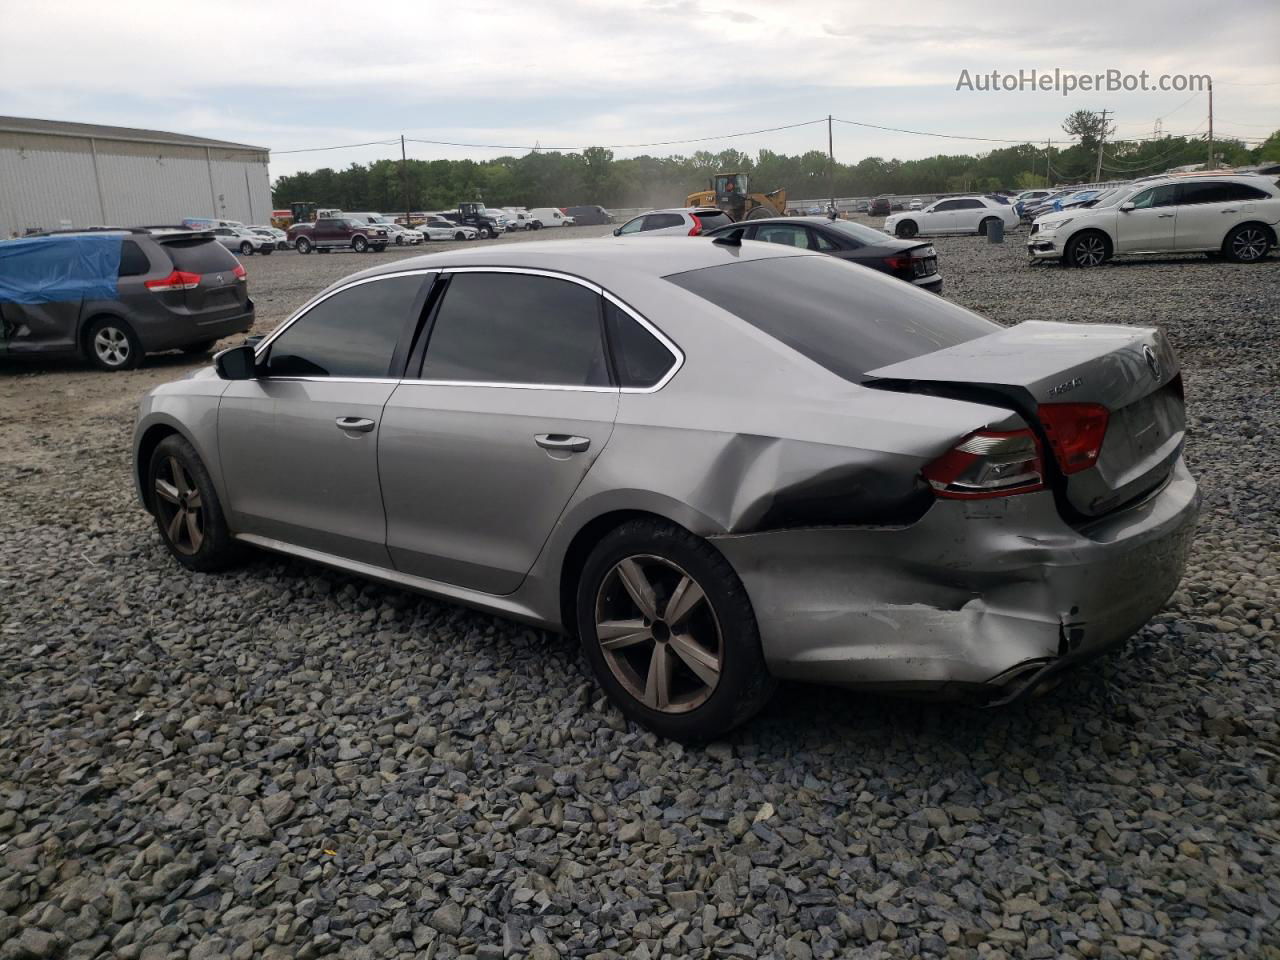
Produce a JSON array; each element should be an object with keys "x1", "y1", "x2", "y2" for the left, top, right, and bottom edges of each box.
[{"x1": 253, "y1": 266, "x2": 685, "y2": 394}]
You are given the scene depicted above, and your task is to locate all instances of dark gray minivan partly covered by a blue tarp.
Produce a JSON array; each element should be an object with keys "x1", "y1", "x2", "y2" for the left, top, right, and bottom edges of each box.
[{"x1": 0, "y1": 228, "x2": 253, "y2": 370}]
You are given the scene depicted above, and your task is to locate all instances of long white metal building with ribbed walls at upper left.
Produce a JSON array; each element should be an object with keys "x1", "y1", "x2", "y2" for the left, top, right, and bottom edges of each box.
[{"x1": 0, "y1": 116, "x2": 271, "y2": 238}]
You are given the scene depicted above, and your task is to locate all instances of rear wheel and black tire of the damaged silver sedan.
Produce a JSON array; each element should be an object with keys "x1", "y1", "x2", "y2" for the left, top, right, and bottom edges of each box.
[{"x1": 576, "y1": 520, "x2": 776, "y2": 740}]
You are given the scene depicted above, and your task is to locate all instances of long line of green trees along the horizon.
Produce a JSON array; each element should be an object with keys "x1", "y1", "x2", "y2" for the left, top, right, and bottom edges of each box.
[{"x1": 271, "y1": 126, "x2": 1280, "y2": 211}]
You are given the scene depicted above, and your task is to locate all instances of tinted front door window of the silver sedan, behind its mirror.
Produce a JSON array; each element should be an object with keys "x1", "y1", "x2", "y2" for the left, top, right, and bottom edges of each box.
[{"x1": 266, "y1": 276, "x2": 424, "y2": 376}]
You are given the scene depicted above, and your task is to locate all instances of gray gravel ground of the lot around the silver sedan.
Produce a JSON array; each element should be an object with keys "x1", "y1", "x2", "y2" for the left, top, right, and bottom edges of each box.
[{"x1": 0, "y1": 228, "x2": 1280, "y2": 960}]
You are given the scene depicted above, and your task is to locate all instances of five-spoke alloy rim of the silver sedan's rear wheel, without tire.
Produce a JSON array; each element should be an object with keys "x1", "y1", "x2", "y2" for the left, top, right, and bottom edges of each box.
[{"x1": 595, "y1": 556, "x2": 724, "y2": 713}]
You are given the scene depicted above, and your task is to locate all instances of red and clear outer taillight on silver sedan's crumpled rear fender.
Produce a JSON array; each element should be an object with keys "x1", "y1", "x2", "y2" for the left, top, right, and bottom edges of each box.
[{"x1": 922, "y1": 430, "x2": 1044, "y2": 500}]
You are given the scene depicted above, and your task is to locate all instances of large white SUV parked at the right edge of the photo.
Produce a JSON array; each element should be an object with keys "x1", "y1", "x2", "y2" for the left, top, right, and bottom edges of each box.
[{"x1": 1027, "y1": 173, "x2": 1280, "y2": 266}]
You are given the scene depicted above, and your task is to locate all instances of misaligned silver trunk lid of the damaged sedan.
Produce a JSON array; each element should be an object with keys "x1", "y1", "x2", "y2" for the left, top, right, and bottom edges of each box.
[{"x1": 867, "y1": 320, "x2": 1185, "y2": 517}]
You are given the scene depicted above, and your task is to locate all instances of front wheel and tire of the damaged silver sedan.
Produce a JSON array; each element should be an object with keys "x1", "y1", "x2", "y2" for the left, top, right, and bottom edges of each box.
[{"x1": 146, "y1": 434, "x2": 243, "y2": 572}]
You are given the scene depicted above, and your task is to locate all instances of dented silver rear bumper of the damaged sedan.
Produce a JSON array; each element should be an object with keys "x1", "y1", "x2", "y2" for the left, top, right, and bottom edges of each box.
[{"x1": 713, "y1": 458, "x2": 1199, "y2": 699}]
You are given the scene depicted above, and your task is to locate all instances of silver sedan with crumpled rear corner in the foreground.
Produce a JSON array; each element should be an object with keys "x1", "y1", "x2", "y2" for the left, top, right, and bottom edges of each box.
[{"x1": 133, "y1": 238, "x2": 1199, "y2": 739}]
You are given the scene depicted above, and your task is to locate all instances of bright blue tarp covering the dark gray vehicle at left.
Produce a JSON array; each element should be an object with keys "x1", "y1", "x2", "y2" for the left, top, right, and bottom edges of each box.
[{"x1": 0, "y1": 234, "x2": 123, "y2": 303}]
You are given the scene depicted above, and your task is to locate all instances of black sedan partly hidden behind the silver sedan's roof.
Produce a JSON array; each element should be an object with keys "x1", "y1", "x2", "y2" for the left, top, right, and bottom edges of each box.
[{"x1": 704, "y1": 216, "x2": 942, "y2": 293}]
